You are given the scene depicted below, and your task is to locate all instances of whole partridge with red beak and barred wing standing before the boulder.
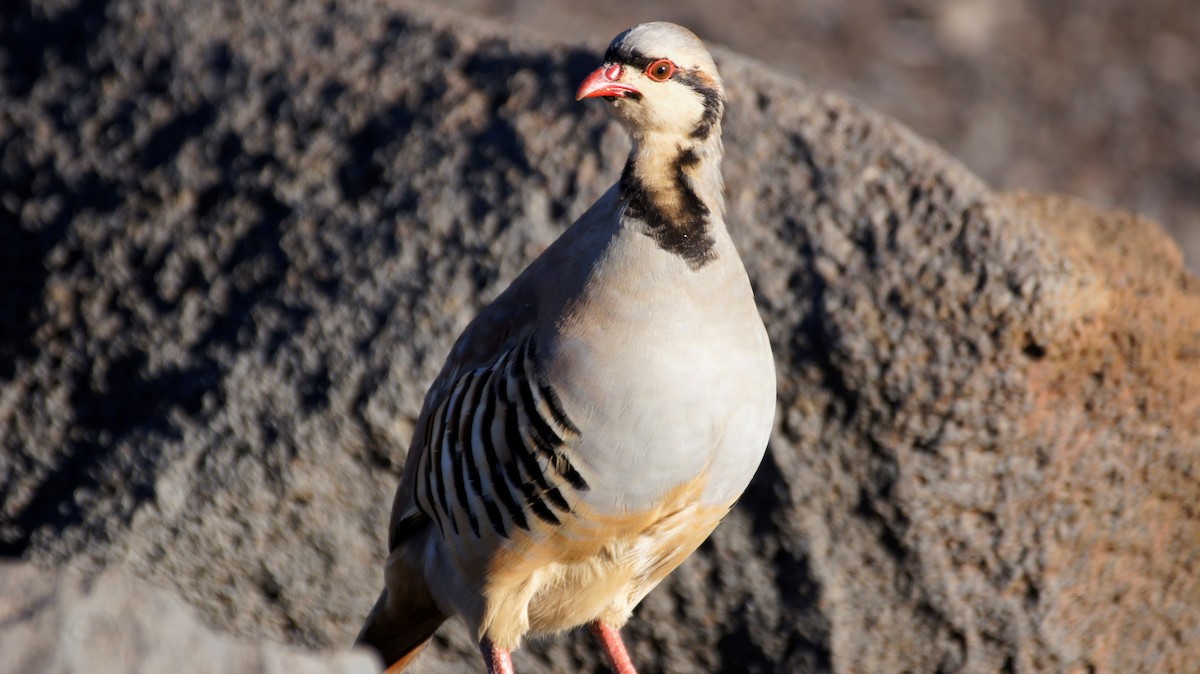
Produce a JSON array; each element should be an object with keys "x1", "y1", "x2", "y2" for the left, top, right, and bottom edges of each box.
[{"x1": 358, "y1": 22, "x2": 775, "y2": 674}]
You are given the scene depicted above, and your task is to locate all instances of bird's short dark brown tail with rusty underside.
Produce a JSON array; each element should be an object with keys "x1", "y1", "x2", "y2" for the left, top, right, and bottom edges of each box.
[{"x1": 355, "y1": 580, "x2": 446, "y2": 674}]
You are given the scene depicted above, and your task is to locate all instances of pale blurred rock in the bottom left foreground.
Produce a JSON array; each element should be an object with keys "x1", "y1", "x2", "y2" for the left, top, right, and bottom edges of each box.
[{"x1": 0, "y1": 564, "x2": 379, "y2": 674}]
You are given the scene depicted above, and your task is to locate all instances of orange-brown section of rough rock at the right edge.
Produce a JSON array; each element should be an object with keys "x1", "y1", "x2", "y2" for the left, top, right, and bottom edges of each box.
[{"x1": 1012, "y1": 195, "x2": 1200, "y2": 672}]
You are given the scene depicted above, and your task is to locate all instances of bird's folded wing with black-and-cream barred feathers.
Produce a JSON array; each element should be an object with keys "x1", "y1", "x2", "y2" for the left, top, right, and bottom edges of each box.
[{"x1": 389, "y1": 186, "x2": 619, "y2": 550}]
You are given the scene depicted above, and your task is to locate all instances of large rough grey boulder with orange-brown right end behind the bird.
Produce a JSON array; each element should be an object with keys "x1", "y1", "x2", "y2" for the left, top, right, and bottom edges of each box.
[{"x1": 0, "y1": 0, "x2": 1200, "y2": 673}]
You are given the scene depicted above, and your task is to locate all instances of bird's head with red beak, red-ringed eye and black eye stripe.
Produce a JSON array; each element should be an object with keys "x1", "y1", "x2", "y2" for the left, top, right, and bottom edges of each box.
[{"x1": 575, "y1": 22, "x2": 725, "y2": 140}]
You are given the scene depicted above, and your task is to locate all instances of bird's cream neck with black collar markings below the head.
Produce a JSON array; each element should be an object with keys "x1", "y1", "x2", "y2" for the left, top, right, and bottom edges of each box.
[{"x1": 620, "y1": 130, "x2": 725, "y2": 269}]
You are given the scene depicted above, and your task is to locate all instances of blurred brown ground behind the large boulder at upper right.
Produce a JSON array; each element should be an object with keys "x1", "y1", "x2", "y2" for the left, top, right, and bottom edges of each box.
[{"x1": 426, "y1": 0, "x2": 1200, "y2": 270}]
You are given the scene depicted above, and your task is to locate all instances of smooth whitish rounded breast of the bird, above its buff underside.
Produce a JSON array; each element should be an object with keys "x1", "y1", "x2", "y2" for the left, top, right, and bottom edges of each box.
[{"x1": 552, "y1": 265, "x2": 775, "y2": 513}]
